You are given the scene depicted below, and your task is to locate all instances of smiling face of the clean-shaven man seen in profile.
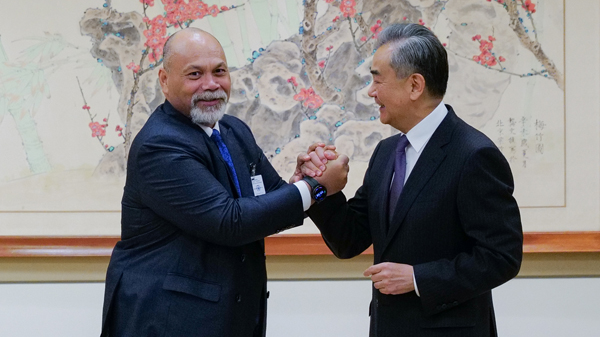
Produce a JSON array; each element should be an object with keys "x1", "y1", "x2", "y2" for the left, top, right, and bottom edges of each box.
[{"x1": 369, "y1": 44, "x2": 412, "y2": 132}]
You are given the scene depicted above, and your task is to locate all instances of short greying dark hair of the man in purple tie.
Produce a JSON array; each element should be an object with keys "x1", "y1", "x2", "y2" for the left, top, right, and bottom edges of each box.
[{"x1": 376, "y1": 23, "x2": 448, "y2": 97}]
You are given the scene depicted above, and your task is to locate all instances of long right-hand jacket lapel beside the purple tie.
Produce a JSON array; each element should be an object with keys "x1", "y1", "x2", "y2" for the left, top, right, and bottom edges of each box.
[{"x1": 382, "y1": 106, "x2": 456, "y2": 252}]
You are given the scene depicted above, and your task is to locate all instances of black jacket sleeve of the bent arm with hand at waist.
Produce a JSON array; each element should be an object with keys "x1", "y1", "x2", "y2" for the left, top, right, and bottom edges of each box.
[{"x1": 414, "y1": 147, "x2": 523, "y2": 314}]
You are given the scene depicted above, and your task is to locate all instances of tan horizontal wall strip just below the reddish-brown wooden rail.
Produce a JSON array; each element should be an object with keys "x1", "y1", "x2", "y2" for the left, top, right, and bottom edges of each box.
[{"x1": 0, "y1": 253, "x2": 600, "y2": 282}]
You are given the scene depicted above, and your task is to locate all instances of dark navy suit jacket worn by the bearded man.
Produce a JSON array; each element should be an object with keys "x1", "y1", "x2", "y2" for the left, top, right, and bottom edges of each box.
[{"x1": 102, "y1": 102, "x2": 304, "y2": 337}]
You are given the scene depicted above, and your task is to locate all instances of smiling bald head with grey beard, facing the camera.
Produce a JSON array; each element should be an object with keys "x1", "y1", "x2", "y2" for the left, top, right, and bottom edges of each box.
[{"x1": 158, "y1": 29, "x2": 231, "y2": 127}]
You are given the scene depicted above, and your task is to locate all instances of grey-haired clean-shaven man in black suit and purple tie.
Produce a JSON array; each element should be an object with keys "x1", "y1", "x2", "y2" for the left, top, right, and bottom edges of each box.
[{"x1": 304, "y1": 24, "x2": 523, "y2": 337}]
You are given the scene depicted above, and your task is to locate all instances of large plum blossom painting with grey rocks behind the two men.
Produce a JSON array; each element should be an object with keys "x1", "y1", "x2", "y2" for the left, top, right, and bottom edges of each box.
[{"x1": 0, "y1": 0, "x2": 566, "y2": 234}]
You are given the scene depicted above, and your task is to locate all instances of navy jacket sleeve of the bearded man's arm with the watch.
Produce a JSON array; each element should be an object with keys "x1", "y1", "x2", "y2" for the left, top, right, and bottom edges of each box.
[{"x1": 133, "y1": 135, "x2": 304, "y2": 246}]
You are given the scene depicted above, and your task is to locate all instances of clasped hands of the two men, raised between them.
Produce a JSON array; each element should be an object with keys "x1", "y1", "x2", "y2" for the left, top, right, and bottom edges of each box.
[{"x1": 289, "y1": 143, "x2": 350, "y2": 202}]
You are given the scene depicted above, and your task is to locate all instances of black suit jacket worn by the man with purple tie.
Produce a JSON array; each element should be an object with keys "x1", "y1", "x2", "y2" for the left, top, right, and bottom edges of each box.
[{"x1": 309, "y1": 106, "x2": 523, "y2": 337}]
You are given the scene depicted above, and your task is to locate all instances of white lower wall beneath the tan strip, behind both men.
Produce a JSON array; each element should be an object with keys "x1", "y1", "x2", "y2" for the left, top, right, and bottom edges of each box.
[{"x1": 0, "y1": 277, "x2": 600, "y2": 337}]
